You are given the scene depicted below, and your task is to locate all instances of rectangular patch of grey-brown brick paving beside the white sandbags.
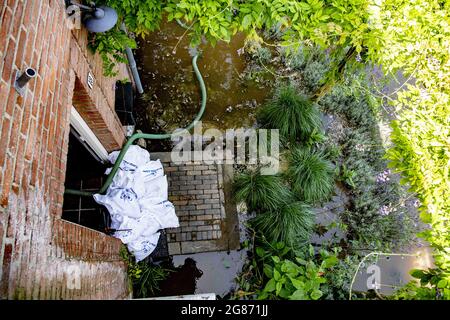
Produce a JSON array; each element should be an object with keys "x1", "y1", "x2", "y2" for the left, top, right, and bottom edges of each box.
[{"x1": 151, "y1": 153, "x2": 239, "y2": 255}]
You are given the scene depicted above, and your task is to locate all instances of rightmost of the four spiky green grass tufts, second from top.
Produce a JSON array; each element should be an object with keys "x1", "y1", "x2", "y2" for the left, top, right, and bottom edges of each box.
[{"x1": 287, "y1": 147, "x2": 334, "y2": 203}]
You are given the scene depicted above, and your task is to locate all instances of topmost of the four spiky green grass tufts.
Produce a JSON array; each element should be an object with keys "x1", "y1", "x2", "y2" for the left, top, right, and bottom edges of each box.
[{"x1": 258, "y1": 85, "x2": 321, "y2": 142}]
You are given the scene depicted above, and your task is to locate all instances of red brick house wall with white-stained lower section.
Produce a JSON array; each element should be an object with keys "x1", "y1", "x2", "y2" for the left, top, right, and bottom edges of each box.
[{"x1": 0, "y1": 0, "x2": 128, "y2": 299}]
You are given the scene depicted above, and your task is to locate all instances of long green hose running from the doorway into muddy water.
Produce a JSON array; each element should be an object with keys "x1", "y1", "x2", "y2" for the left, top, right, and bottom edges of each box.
[{"x1": 64, "y1": 55, "x2": 207, "y2": 197}]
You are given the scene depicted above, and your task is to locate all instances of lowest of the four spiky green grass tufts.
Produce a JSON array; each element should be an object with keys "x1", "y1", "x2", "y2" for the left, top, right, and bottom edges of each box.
[{"x1": 251, "y1": 202, "x2": 314, "y2": 249}]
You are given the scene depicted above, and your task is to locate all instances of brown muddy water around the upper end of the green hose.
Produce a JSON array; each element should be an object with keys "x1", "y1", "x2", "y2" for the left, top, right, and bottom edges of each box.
[{"x1": 136, "y1": 23, "x2": 270, "y2": 132}]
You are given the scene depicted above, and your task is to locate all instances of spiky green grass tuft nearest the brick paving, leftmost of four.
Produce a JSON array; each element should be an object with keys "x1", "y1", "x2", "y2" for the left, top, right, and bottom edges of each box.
[{"x1": 233, "y1": 170, "x2": 292, "y2": 211}]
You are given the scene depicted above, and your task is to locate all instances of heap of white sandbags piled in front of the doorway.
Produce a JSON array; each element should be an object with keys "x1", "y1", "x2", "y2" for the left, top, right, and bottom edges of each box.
[{"x1": 94, "y1": 146, "x2": 179, "y2": 261}]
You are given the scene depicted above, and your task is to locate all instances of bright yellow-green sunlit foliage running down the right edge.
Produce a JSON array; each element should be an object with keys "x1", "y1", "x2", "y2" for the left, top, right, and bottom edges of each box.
[{"x1": 373, "y1": 0, "x2": 450, "y2": 299}]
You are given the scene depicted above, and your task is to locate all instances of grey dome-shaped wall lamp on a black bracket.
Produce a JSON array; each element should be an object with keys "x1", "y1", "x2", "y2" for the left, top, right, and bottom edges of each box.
[{"x1": 65, "y1": 0, "x2": 118, "y2": 32}]
